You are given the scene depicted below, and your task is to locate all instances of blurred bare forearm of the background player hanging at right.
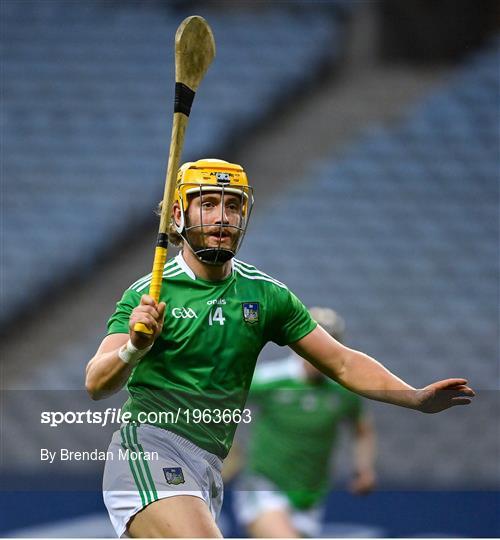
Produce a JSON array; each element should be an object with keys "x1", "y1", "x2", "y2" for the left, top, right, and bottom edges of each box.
[{"x1": 350, "y1": 414, "x2": 376, "y2": 495}]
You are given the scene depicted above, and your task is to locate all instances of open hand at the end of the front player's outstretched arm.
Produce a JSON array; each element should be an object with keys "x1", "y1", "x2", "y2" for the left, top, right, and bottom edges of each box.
[{"x1": 415, "y1": 379, "x2": 475, "y2": 413}]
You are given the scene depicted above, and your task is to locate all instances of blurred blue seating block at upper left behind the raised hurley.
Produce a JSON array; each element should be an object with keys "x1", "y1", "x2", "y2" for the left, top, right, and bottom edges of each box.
[{"x1": 1, "y1": 0, "x2": 341, "y2": 321}]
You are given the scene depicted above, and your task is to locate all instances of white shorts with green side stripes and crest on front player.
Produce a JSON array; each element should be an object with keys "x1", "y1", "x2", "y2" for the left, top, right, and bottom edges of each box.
[{"x1": 103, "y1": 424, "x2": 224, "y2": 537}]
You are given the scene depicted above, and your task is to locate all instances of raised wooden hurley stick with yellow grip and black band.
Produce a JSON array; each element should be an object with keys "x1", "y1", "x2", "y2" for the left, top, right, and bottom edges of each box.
[{"x1": 134, "y1": 15, "x2": 215, "y2": 335}]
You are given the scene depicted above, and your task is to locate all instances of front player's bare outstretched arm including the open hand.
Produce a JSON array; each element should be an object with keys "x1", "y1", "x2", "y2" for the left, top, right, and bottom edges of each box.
[{"x1": 290, "y1": 326, "x2": 474, "y2": 413}]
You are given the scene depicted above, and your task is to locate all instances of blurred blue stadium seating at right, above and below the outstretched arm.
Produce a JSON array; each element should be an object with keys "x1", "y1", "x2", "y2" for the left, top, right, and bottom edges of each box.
[{"x1": 241, "y1": 40, "x2": 500, "y2": 486}]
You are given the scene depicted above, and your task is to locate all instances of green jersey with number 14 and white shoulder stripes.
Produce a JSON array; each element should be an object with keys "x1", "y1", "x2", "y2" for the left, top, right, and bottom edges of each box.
[{"x1": 108, "y1": 254, "x2": 316, "y2": 458}]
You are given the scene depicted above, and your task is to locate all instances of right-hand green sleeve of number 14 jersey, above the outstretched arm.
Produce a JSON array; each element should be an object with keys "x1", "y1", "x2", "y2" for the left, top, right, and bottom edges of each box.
[{"x1": 269, "y1": 289, "x2": 317, "y2": 346}]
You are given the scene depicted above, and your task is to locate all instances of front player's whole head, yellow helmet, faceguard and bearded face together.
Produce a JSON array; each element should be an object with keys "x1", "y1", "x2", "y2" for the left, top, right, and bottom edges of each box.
[{"x1": 174, "y1": 159, "x2": 253, "y2": 265}]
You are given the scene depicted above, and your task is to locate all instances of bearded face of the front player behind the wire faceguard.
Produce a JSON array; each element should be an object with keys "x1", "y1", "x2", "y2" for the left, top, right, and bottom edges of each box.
[{"x1": 186, "y1": 191, "x2": 243, "y2": 250}]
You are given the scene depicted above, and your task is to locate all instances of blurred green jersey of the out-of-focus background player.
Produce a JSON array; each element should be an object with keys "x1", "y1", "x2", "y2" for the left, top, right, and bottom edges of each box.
[{"x1": 248, "y1": 356, "x2": 362, "y2": 509}]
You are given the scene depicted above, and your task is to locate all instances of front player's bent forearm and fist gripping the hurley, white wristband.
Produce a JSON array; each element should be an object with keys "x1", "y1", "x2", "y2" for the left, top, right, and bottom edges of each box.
[{"x1": 85, "y1": 295, "x2": 165, "y2": 399}]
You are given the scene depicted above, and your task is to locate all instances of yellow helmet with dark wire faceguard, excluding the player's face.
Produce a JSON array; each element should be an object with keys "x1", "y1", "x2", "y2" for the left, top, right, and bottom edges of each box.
[{"x1": 174, "y1": 159, "x2": 253, "y2": 264}]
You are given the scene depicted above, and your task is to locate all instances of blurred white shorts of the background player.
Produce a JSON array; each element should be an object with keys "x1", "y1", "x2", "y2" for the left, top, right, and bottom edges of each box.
[{"x1": 233, "y1": 474, "x2": 323, "y2": 537}]
